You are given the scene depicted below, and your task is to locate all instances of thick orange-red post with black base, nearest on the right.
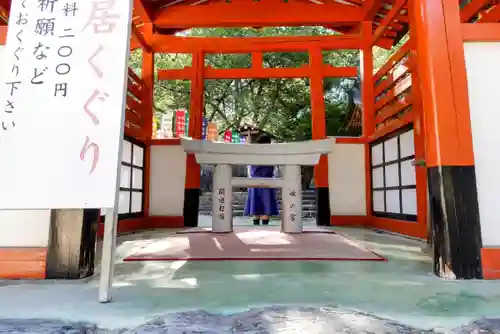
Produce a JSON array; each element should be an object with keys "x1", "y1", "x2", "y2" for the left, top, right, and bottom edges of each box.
[{"x1": 409, "y1": 0, "x2": 482, "y2": 279}]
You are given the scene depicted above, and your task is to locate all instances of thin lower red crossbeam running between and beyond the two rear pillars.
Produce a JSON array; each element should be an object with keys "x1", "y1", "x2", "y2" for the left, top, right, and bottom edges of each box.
[{"x1": 158, "y1": 65, "x2": 358, "y2": 80}]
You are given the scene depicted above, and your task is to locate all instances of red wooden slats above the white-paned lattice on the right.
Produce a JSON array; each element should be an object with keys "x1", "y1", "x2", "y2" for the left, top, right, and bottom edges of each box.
[{"x1": 373, "y1": 41, "x2": 415, "y2": 134}]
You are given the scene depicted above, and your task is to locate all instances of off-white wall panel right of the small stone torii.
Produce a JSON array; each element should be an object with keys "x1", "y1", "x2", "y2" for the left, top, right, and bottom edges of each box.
[{"x1": 328, "y1": 144, "x2": 366, "y2": 216}]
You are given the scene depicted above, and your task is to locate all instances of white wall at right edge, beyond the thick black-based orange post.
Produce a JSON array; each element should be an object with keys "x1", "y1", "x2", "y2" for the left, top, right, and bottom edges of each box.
[{"x1": 464, "y1": 42, "x2": 500, "y2": 247}]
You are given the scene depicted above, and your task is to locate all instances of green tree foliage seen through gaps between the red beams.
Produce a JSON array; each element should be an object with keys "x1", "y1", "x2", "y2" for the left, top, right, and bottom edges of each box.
[{"x1": 130, "y1": 27, "x2": 402, "y2": 141}]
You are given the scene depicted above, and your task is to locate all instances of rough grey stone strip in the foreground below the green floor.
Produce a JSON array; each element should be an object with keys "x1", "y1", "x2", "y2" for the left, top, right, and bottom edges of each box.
[{"x1": 0, "y1": 306, "x2": 500, "y2": 334}]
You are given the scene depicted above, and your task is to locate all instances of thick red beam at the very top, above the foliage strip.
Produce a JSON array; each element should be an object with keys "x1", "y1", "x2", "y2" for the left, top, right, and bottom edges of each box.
[{"x1": 154, "y1": 0, "x2": 365, "y2": 29}]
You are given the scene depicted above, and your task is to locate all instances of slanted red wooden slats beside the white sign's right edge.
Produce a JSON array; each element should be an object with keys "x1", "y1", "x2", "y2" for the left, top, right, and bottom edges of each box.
[{"x1": 125, "y1": 67, "x2": 148, "y2": 139}]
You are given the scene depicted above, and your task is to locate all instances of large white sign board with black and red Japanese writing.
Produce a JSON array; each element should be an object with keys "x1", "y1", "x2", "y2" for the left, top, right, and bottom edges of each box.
[{"x1": 0, "y1": 0, "x2": 131, "y2": 209}]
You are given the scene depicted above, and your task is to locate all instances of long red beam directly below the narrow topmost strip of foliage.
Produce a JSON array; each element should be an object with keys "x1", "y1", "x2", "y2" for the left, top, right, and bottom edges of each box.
[{"x1": 150, "y1": 34, "x2": 364, "y2": 53}]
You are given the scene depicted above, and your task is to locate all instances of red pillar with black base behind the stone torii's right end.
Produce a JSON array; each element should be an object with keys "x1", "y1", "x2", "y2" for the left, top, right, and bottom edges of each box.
[{"x1": 309, "y1": 48, "x2": 331, "y2": 226}]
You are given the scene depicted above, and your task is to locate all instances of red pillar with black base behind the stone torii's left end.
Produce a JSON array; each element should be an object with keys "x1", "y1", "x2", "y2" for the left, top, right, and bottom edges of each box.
[{"x1": 183, "y1": 50, "x2": 205, "y2": 227}]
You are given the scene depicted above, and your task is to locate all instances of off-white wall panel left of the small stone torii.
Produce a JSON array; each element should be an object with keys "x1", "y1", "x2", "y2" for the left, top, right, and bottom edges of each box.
[{"x1": 149, "y1": 145, "x2": 186, "y2": 216}]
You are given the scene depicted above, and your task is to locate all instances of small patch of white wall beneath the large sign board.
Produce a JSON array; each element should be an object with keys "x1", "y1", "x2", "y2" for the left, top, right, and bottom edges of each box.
[{"x1": 0, "y1": 210, "x2": 50, "y2": 247}]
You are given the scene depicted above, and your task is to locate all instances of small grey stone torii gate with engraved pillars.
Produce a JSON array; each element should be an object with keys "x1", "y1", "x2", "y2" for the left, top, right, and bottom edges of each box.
[{"x1": 181, "y1": 138, "x2": 335, "y2": 233}]
